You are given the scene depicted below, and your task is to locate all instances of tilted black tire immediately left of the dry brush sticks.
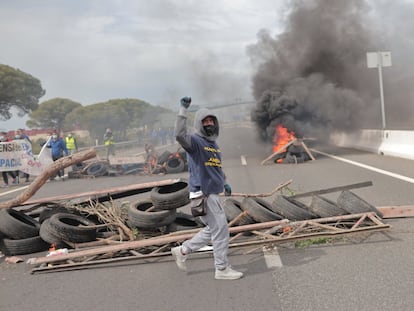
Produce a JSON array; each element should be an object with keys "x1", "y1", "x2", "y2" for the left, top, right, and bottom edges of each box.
[{"x1": 50, "y1": 213, "x2": 96, "y2": 243}]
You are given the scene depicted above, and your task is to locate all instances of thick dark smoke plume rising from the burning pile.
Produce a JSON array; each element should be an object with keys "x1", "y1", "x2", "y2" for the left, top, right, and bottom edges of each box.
[{"x1": 248, "y1": 0, "x2": 413, "y2": 141}]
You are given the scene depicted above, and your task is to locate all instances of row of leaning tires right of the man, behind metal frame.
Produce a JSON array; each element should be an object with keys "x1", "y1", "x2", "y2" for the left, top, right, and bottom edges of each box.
[{"x1": 223, "y1": 190, "x2": 382, "y2": 225}]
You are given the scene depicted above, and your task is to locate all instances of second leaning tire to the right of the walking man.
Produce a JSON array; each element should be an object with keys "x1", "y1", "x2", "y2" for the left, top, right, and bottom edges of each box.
[{"x1": 241, "y1": 197, "x2": 283, "y2": 222}]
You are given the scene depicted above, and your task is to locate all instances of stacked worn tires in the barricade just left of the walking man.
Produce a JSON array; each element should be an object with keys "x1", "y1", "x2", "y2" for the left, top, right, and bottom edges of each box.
[{"x1": 127, "y1": 179, "x2": 200, "y2": 232}]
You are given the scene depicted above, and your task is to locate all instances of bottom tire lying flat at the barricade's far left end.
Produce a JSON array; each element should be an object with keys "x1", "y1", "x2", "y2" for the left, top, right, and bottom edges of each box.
[{"x1": 0, "y1": 236, "x2": 49, "y2": 256}]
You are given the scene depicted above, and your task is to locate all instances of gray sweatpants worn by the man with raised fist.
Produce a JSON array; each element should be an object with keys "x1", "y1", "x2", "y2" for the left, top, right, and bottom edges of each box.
[{"x1": 183, "y1": 194, "x2": 229, "y2": 270}]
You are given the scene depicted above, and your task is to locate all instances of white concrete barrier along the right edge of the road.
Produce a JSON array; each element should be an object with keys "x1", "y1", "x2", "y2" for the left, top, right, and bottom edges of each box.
[{"x1": 331, "y1": 130, "x2": 414, "y2": 160}]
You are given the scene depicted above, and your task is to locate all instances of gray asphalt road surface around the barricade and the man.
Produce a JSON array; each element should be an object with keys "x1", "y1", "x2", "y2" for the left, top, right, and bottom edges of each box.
[{"x1": 0, "y1": 125, "x2": 414, "y2": 311}]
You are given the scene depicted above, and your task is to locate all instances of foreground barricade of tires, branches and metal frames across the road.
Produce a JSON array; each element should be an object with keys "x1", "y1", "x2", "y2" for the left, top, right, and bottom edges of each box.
[{"x1": 0, "y1": 179, "x2": 414, "y2": 273}]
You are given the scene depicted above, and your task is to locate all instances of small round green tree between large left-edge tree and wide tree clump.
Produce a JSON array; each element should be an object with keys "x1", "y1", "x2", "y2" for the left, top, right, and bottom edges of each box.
[{"x1": 26, "y1": 98, "x2": 82, "y2": 131}]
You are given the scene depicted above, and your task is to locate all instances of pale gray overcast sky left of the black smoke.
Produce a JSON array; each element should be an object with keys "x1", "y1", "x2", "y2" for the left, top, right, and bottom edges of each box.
[{"x1": 0, "y1": 0, "x2": 282, "y2": 129}]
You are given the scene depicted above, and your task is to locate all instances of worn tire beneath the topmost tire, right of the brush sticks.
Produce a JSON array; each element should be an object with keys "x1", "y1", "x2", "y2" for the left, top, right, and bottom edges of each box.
[{"x1": 128, "y1": 199, "x2": 177, "y2": 229}]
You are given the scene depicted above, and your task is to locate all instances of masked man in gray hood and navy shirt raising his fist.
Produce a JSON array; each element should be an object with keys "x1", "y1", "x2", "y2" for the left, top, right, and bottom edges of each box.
[{"x1": 171, "y1": 97, "x2": 243, "y2": 280}]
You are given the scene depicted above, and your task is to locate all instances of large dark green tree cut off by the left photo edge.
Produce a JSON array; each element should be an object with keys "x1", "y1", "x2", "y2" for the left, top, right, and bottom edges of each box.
[{"x1": 0, "y1": 64, "x2": 45, "y2": 120}]
